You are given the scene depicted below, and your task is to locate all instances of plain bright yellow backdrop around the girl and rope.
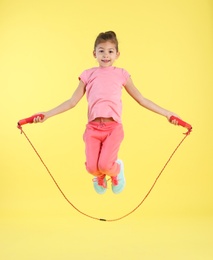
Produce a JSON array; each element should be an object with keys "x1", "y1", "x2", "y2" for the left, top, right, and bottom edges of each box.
[{"x1": 0, "y1": 0, "x2": 213, "y2": 260}]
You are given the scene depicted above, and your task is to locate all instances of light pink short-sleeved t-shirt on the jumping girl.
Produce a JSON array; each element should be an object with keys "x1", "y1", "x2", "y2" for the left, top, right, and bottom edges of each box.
[{"x1": 79, "y1": 67, "x2": 129, "y2": 123}]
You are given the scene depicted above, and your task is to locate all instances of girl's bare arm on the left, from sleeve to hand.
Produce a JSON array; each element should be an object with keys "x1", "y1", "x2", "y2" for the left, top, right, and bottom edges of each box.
[{"x1": 34, "y1": 80, "x2": 85, "y2": 123}]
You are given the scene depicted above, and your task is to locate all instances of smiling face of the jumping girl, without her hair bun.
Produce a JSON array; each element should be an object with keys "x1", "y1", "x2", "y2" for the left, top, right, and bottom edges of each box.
[{"x1": 93, "y1": 41, "x2": 120, "y2": 67}]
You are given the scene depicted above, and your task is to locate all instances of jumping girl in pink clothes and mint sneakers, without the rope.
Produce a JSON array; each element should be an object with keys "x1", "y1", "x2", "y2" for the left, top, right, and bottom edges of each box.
[{"x1": 34, "y1": 31, "x2": 178, "y2": 194}]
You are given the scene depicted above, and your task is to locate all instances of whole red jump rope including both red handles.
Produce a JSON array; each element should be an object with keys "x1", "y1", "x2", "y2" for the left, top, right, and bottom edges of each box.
[{"x1": 17, "y1": 114, "x2": 192, "y2": 222}]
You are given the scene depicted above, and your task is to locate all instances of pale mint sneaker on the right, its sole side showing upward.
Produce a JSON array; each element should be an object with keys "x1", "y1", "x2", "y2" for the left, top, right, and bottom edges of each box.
[{"x1": 111, "y1": 159, "x2": 126, "y2": 194}]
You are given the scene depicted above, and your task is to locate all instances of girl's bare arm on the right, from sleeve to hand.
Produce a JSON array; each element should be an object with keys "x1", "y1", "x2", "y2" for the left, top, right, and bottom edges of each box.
[{"x1": 124, "y1": 77, "x2": 181, "y2": 124}]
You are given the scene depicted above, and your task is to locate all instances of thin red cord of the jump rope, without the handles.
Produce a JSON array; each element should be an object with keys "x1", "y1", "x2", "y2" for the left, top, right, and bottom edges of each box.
[{"x1": 18, "y1": 125, "x2": 190, "y2": 222}]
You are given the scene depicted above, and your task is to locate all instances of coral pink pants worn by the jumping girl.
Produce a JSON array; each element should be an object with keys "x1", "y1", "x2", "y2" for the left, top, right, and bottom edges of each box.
[{"x1": 83, "y1": 121, "x2": 124, "y2": 176}]
